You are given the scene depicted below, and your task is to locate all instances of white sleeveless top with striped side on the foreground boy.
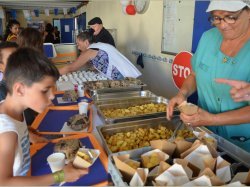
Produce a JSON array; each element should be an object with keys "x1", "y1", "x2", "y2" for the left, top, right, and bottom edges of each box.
[{"x1": 0, "y1": 114, "x2": 31, "y2": 176}]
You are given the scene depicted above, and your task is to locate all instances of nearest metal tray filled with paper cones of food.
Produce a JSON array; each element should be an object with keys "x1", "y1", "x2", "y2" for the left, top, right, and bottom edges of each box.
[{"x1": 109, "y1": 131, "x2": 250, "y2": 186}]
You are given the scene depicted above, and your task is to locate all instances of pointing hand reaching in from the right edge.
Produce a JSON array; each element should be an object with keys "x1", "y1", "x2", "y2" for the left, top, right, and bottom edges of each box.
[{"x1": 215, "y1": 79, "x2": 250, "y2": 102}]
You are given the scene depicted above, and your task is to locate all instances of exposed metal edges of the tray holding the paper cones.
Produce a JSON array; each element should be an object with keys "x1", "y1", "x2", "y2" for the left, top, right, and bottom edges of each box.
[{"x1": 108, "y1": 133, "x2": 250, "y2": 186}]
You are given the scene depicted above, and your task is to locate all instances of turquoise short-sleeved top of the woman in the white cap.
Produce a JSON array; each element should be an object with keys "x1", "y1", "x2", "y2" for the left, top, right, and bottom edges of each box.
[{"x1": 192, "y1": 28, "x2": 250, "y2": 152}]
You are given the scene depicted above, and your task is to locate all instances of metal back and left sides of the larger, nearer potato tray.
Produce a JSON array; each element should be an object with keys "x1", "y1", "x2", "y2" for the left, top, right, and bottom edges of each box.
[{"x1": 96, "y1": 117, "x2": 180, "y2": 155}]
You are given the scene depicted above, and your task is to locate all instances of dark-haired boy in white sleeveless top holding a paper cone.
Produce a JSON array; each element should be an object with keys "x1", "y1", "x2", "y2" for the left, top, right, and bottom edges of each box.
[{"x1": 0, "y1": 48, "x2": 87, "y2": 186}]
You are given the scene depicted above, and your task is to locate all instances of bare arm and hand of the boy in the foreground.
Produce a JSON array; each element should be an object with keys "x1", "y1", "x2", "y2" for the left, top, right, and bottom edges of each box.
[{"x1": 0, "y1": 132, "x2": 88, "y2": 186}]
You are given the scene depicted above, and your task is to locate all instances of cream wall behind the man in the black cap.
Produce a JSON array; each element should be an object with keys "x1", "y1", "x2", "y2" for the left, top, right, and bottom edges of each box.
[{"x1": 86, "y1": 0, "x2": 193, "y2": 98}]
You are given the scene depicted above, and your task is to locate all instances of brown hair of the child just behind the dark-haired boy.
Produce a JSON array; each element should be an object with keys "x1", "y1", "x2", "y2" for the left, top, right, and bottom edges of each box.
[{"x1": 17, "y1": 28, "x2": 43, "y2": 52}]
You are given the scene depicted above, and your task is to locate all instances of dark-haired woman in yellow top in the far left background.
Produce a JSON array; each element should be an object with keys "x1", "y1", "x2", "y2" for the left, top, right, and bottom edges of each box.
[{"x1": 4, "y1": 19, "x2": 20, "y2": 42}]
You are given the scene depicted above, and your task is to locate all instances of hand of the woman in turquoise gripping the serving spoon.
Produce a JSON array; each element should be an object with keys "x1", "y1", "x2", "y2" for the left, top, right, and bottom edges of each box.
[{"x1": 166, "y1": 92, "x2": 187, "y2": 120}]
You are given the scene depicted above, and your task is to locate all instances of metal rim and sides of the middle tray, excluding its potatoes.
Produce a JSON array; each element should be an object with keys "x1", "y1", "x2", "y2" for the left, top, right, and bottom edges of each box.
[{"x1": 96, "y1": 97, "x2": 168, "y2": 124}]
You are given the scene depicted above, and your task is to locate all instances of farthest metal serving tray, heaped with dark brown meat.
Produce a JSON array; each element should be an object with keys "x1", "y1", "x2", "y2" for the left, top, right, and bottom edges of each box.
[{"x1": 84, "y1": 78, "x2": 147, "y2": 96}]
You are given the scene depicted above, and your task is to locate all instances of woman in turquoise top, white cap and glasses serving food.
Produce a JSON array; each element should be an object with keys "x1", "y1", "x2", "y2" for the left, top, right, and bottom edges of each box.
[{"x1": 167, "y1": 0, "x2": 250, "y2": 152}]
